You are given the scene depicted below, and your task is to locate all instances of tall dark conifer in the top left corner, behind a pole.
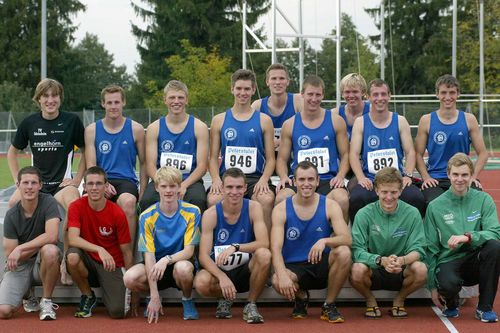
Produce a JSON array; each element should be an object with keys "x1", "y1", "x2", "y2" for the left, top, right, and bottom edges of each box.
[{"x1": 0, "y1": 0, "x2": 85, "y2": 89}]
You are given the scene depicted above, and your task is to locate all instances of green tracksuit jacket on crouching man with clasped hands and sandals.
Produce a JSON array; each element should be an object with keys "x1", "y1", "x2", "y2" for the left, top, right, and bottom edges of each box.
[{"x1": 352, "y1": 200, "x2": 425, "y2": 268}]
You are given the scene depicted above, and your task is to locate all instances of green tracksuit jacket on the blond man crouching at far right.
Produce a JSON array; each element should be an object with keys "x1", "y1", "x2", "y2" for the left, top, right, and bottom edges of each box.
[{"x1": 424, "y1": 188, "x2": 500, "y2": 290}]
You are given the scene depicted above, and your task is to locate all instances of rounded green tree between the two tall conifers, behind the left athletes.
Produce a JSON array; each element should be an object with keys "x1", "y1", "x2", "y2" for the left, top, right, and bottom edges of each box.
[{"x1": 58, "y1": 34, "x2": 131, "y2": 111}]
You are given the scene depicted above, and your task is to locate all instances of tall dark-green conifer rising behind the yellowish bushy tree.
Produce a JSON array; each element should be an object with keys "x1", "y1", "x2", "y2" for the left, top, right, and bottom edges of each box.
[{"x1": 132, "y1": 0, "x2": 269, "y2": 104}]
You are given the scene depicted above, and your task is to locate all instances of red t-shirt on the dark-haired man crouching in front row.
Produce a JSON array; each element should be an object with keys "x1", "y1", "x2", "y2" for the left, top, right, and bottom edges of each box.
[{"x1": 68, "y1": 196, "x2": 131, "y2": 267}]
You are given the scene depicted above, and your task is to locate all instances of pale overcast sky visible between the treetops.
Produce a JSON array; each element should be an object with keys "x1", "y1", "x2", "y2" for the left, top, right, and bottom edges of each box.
[{"x1": 73, "y1": 0, "x2": 381, "y2": 74}]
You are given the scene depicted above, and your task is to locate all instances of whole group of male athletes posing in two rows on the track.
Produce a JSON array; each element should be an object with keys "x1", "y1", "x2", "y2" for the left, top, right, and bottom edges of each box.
[{"x1": 0, "y1": 64, "x2": 500, "y2": 323}]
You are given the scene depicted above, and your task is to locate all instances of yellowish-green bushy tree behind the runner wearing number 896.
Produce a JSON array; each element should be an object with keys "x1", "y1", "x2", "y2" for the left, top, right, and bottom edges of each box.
[{"x1": 146, "y1": 39, "x2": 233, "y2": 108}]
